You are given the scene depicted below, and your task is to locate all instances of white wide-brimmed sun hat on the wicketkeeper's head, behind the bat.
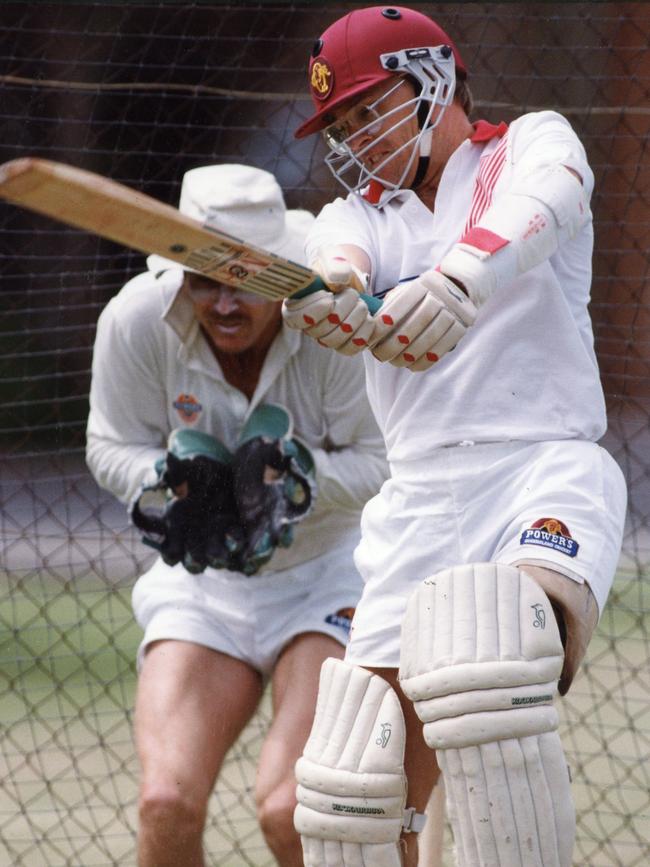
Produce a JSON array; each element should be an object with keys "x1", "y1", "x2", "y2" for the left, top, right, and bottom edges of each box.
[{"x1": 147, "y1": 163, "x2": 315, "y2": 273}]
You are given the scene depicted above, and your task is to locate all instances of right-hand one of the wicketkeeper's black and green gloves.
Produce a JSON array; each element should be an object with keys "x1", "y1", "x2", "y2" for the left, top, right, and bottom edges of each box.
[{"x1": 232, "y1": 404, "x2": 316, "y2": 575}]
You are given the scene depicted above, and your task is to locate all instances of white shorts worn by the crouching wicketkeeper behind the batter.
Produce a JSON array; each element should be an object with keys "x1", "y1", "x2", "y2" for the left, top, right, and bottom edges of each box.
[{"x1": 132, "y1": 536, "x2": 362, "y2": 676}]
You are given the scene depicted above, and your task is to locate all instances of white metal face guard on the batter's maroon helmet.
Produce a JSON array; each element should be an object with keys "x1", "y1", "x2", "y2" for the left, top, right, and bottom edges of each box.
[{"x1": 323, "y1": 45, "x2": 456, "y2": 203}]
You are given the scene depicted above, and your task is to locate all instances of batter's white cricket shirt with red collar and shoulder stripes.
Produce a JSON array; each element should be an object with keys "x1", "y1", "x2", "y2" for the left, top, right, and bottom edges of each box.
[{"x1": 307, "y1": 111, "x2": 606, "y2": 469}]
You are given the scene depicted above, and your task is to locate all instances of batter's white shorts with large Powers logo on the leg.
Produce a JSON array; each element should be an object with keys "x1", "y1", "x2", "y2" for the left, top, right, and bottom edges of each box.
[{"x1": 346, "y1": 440, "x2": 626, "y2": 668}]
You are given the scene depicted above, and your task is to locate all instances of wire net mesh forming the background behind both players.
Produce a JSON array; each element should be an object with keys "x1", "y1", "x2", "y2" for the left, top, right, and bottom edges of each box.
[{"x1": 0, "y1": 2, "x2": 650, "y2": 867}]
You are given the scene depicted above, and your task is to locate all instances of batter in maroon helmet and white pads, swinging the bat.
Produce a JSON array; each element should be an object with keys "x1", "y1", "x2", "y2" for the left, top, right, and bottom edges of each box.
[{"x1": 284, "y1": 6, "x2": 626, "y2": 867}]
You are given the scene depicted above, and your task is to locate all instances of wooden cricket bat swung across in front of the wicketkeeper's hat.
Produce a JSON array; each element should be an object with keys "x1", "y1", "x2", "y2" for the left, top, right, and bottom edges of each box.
[{"x1": 0, "y1": 157, "x2": 381, "y2": 313}]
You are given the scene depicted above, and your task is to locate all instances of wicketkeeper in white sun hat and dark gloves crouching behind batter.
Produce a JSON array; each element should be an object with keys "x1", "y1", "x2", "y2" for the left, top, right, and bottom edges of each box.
[{"x1": 87, "y1": 165, "x2": 387, "y2": 867}]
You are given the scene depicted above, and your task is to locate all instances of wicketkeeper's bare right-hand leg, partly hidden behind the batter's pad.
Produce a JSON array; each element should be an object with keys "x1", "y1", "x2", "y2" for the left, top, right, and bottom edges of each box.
[{"x1": 255, "y1": 632, "x2": 344, "y2": 867}]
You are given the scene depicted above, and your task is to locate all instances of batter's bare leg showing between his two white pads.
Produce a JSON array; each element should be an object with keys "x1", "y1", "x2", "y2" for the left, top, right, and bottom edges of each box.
[{"x1": 370, "y1": 668, "x2": 440, "y2": 867}]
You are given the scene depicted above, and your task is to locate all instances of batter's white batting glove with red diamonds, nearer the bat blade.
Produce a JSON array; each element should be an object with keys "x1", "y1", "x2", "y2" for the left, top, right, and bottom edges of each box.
[{"x1": 282, "y1": 256, "x2": 374, "y2": 355}]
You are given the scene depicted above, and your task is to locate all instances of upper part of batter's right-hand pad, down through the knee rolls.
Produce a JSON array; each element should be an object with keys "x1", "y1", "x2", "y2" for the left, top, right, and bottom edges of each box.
[{"x1": 400, "y1": 563, "x2": 564, "y2": 749}]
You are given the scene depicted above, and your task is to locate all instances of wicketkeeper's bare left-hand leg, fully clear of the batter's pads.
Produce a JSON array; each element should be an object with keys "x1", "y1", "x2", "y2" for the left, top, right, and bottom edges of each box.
[{"x1": 135, "y1": 641, "x2": 262, "y2": 867}]
